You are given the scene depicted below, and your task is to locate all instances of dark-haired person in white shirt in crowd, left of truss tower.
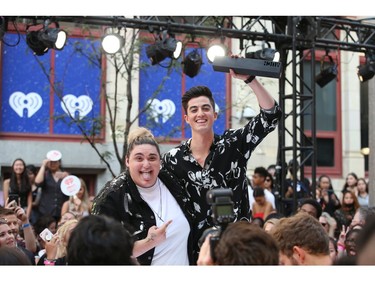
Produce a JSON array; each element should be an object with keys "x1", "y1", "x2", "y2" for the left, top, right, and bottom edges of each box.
[{"x1": 248, "y1": 166, "x2": 276, "y2": 210}]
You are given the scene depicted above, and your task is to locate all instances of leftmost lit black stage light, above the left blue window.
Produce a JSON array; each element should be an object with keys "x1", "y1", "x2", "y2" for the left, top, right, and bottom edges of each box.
[{"x1": 26, "y1": 20, "x2": 67, "y2": 56}]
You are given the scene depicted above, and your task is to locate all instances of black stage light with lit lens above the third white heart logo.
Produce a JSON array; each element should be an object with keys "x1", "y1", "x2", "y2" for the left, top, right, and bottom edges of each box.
[{"x1": 146, "y1": 30, "x2": 182, "y2": 65}]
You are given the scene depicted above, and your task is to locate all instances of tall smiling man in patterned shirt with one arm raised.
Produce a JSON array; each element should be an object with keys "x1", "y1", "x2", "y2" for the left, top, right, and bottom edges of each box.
[{"x1": 163, "y1": 66, "x2": 282, "y2": 257}]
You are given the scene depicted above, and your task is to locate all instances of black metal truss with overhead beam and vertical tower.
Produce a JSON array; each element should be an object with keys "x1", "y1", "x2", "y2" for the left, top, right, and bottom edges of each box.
[{"x1": 8, "y1": 16, "x2": 375, "y2": 211}]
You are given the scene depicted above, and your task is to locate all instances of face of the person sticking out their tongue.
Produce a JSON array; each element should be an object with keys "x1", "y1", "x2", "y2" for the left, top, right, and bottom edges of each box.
[{"x1": 126, "y1": 144, "x2": 160, "y2": 187}]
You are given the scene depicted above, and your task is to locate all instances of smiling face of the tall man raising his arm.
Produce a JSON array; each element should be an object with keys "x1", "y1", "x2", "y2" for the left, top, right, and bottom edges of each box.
[{"x1": 185, "y1": 96, "x2": 217, "y2": 132}]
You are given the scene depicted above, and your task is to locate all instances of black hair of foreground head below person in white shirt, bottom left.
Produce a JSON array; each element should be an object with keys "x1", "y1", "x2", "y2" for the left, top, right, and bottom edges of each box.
[{"x1": 66, "y1": 215, "x2": 136, "y2": 265}]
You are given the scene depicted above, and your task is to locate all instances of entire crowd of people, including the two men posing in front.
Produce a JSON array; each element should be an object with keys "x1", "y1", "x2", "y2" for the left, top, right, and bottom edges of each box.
[{"x1": 0, "y1": 66, "x2": 375, "y2": 266}]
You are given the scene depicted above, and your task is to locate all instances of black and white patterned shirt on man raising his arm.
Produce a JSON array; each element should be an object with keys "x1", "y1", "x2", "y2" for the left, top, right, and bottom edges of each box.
[{"x1": 162, "y1": 102, "x2": 281, "y2": 253}]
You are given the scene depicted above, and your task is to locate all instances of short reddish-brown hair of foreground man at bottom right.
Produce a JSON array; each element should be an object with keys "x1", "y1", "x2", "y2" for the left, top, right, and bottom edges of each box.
[{"x1": 270, "y1": 212, "x2": 329, "y2": 258}]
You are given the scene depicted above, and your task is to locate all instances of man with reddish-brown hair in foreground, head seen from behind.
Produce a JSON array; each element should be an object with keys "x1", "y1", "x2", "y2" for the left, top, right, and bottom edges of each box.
[{"x1": 270, "y1": 212, "x2": 332, "y2": 265}]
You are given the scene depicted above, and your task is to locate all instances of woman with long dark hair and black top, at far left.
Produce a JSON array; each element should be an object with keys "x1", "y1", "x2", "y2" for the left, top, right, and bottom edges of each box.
[{"x1": 3, "y1": 158, "x2": 33, "y2": 218}]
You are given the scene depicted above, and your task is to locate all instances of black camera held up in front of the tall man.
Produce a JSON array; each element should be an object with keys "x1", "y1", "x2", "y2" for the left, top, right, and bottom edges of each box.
[{"x1": 199, "y1": 188, "x2": 235, "y2": 262}]
